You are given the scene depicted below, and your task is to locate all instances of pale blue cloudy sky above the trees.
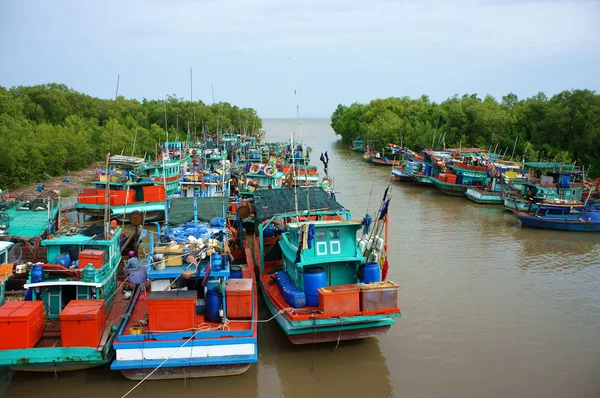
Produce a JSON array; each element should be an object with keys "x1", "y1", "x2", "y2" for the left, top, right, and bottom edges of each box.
[{"x1": 0, "y1": 0, "x2": 600, "y2": 118}]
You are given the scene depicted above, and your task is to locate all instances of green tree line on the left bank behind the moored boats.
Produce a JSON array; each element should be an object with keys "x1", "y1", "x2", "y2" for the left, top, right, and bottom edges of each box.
[{"x1": 0, "y1": 83, "x2": 262, "y2": 188}]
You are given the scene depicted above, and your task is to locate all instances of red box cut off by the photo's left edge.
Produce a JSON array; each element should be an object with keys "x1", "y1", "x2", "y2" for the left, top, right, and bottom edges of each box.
[{"x1": 0, "y1": 301, "x2": 44, "y2": 350}]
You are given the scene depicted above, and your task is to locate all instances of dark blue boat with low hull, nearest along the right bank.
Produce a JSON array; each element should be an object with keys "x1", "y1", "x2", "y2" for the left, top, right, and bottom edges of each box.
[{"x1": 512, "y1": 205, "x2": 600, "y2": 232}]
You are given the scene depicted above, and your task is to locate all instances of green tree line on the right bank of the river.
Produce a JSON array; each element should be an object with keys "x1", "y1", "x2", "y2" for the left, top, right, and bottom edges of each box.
[{"x1": 331, "y1": 90, "x2": 600, "y2": 177}]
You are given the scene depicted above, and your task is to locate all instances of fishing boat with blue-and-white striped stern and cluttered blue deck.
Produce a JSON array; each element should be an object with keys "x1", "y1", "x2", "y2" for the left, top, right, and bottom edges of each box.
[{"x1": 111, "y1": 215, "x2": 258, "y2": 380}]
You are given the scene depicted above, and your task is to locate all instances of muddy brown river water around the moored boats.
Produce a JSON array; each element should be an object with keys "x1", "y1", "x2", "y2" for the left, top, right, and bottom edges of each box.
[{"x1": 0, "y1": 120, "x2": 600, "y2": 398}]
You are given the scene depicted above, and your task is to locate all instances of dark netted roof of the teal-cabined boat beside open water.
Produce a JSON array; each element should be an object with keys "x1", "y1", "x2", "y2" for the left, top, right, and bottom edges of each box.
[{"x1": 254, "y1": 187, "x2": 345, "y2": 222}]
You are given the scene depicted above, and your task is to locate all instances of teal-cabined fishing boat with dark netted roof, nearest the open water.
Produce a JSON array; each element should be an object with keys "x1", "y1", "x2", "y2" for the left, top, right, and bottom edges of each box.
[{"x1": 254, "y1": 187, "x2": 401, "y2": 344}]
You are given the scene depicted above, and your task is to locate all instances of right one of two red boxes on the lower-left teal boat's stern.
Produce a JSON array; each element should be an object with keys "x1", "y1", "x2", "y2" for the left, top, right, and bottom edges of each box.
[{"x1": 60, "y1": 300, "x2": 106, "y2": 347}]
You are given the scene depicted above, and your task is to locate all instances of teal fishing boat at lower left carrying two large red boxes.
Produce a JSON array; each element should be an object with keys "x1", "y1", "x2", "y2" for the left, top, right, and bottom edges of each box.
[{"x1": 0, "y1": 226, "x2": 137, "y2": 372}]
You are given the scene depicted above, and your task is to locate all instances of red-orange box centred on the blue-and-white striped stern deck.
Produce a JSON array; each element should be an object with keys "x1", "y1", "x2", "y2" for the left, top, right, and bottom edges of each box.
[{"x1": 146, "y1": 290, "x2": 197, "y2": 332}]
